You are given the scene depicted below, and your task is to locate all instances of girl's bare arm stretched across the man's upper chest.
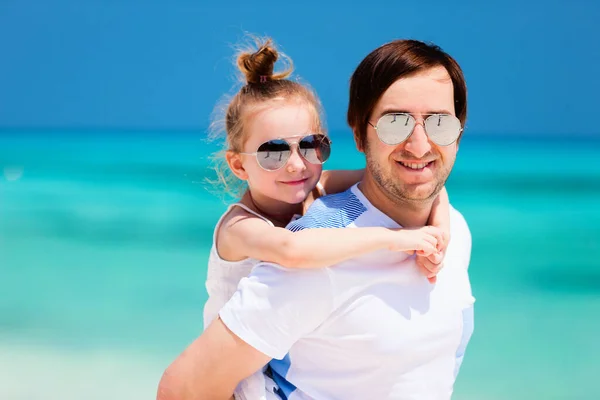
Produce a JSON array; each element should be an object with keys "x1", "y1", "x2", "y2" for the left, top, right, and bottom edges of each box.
[{"x1": 218, "y1": 214, "x2": 442, "y2": 268}]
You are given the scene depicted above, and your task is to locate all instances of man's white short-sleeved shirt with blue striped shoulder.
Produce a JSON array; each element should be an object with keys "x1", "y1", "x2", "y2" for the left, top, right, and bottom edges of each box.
[{"x1": 219, "y1": 185, "x2": 474, "y2": 400}]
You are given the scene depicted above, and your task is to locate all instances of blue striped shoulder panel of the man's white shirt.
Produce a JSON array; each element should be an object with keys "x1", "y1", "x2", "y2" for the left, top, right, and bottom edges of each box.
[{"x1": 287, "y1": 189, "x2": 367, "y2": 232}]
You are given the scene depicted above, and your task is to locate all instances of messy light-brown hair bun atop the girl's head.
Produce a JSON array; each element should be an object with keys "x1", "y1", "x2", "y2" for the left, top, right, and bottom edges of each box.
[{"x1": 237, "y1": 39, "x2": 292, "y2": 84}]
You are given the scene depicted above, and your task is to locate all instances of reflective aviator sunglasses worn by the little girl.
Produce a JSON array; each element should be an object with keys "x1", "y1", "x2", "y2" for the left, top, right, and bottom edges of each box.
[{"x1": 240, "y1": 133, "x2": 331, "y2": 171}]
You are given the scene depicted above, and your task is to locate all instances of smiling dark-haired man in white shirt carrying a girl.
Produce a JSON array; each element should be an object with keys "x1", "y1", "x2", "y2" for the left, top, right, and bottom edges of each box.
[{"x1": 159, "y1": 41, "x2": 474, "y2": 400}]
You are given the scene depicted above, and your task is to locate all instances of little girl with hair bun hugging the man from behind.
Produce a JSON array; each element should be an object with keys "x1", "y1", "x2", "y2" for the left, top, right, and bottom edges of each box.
[{"x1": 204, "y1": 36, "x2": 449, "y2": 399}]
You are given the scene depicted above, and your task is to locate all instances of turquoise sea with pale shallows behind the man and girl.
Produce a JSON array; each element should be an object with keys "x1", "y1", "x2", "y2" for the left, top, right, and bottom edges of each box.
[{"x1": 0, "y1": 131, "x2": 600, "y2": 400}]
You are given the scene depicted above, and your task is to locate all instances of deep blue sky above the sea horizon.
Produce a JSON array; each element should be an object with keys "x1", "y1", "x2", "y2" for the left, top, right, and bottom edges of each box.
[{"x1": 0, "y1": 0, "x2": 600, "y2": 136}]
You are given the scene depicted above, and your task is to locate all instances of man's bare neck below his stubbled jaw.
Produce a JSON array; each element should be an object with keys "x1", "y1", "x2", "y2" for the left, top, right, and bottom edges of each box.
[{"x1": 358, "y1": 173, "x2": 433, "y2": 228}]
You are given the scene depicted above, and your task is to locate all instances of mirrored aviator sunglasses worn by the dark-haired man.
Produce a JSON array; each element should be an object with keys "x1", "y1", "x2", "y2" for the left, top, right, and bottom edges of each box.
[{"x1": 369, "y1": 113, "x2": 463, "y2": 146}]
